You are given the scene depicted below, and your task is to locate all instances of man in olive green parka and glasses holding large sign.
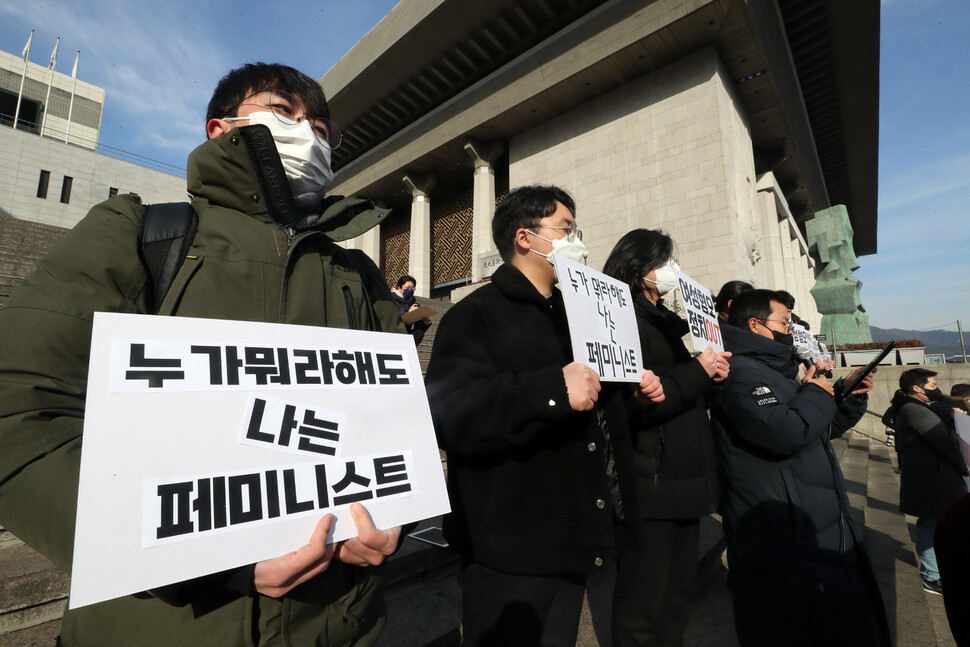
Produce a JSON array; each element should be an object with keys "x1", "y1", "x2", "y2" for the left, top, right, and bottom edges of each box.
[{"x1": 0, "y1": 63, "x2": 404, "y2": 647}]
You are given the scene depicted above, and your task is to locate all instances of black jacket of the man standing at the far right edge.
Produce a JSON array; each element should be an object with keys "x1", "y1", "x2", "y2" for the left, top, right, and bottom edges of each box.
[{"x1": 892, "y1": 391, "x2": 967, "y2": 519}]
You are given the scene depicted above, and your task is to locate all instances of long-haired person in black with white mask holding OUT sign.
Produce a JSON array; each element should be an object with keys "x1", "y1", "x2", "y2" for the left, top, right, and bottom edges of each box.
[{"x1": 604, "y1": 229, "x2": 730, "y2": 647}]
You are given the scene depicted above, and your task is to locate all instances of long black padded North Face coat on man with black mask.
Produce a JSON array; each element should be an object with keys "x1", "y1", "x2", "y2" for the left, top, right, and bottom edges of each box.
[{"x1": 711, "y1": 326, "x2": 866, "y2": 578}]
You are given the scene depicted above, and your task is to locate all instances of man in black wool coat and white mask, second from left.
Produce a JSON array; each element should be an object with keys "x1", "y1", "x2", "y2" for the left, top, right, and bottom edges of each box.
[{"x1": 427, "y1": 186, "x2": 663, "y2": 647}]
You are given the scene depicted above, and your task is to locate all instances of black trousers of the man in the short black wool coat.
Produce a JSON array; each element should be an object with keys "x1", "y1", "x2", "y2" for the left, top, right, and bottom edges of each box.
[{"x1": 458, "y1": 563, "x2": 586, "y2": 647}]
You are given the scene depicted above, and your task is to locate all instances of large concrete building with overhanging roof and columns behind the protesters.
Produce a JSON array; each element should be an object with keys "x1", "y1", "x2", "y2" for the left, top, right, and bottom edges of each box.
[{"x1": 320, "y1": 0, "x2": 878, "y2": 330}]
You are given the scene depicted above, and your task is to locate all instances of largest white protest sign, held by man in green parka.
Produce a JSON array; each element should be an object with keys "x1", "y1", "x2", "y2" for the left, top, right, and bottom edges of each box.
[{"x1": 70, "y1": 313, "x2": 449, "y2": 608}]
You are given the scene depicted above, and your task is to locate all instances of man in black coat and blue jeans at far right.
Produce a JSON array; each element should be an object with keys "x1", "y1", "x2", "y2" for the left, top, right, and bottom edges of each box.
[{"x1": 891, "y1": 368, "x2": 967, "y2": 595}]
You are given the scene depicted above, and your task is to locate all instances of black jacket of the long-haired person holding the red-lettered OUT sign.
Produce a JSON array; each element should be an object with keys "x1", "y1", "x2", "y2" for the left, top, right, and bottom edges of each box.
[{"x1": 629, "y1": 294, "x2": 717, "y2": 519}]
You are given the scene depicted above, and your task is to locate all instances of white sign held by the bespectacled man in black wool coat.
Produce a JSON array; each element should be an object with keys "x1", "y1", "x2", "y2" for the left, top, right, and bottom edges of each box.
[{"x1": 552, "y1": 254, "x2": 643, "y2": 383}]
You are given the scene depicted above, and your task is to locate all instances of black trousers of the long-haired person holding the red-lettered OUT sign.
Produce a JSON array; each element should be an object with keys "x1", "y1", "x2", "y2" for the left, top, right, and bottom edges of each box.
[{"x1": 613, "y1": 519, "x2": 700, "y2": 647}]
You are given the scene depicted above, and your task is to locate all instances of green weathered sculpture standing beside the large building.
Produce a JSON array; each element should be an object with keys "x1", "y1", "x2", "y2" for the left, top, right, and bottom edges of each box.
[{"x1": 805, "y1": 204, "x2": 872, "y2": 346}]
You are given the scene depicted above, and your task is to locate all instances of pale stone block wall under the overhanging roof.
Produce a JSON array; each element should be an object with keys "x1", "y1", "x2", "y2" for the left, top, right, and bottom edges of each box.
[{"x1": 509, "y1": 48, "x2": 816, "y2": 314}]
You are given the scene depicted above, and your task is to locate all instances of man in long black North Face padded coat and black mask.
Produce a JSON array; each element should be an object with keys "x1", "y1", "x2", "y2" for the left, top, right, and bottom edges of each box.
[{"x1": 711, "y1": 290, "x2": 890, "y2": 647}]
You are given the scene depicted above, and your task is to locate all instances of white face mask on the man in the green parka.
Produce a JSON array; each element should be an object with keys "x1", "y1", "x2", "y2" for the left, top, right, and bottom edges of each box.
[{"x1": 229, "y1": 111, "x2": 333, "y2": 195}]
